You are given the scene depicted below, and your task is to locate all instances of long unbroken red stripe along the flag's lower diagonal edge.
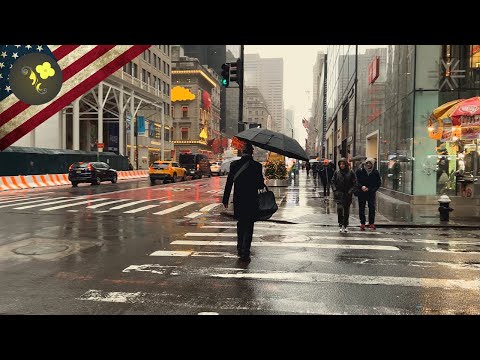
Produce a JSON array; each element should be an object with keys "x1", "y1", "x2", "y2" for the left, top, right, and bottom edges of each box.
[{"x1": 0, "y1": 45, "x2": 151, "y2": 150}]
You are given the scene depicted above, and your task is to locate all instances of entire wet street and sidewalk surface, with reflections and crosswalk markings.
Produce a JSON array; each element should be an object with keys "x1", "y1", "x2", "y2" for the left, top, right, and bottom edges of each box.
[{"x1": 0, "y1": 174, "x2": 480, "y2": 314}]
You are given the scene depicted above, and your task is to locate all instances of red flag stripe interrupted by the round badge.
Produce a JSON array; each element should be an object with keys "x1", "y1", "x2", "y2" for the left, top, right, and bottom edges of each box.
[{"x1": 0, "y1": 45, "x2": 115, "y2": 128}]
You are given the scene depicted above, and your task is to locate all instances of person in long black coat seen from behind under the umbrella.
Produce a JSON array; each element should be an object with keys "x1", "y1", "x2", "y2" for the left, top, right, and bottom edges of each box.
[{"x1": 222, "y1": 143, "x2": 265, "y2": 261}]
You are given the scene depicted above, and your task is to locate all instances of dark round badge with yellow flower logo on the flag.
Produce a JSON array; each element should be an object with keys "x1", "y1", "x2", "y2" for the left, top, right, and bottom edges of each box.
[{"x1": 10, "y1": 53, "x2": 63, "y2": 105}]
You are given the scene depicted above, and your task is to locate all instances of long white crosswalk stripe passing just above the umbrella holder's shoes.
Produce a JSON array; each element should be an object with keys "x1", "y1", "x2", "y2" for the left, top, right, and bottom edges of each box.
[{"x1": 171, "y1": 240, "x2": 400, "y2": 251}]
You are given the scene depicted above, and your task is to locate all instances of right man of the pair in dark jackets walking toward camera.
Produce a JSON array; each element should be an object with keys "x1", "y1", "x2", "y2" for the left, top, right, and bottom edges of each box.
[{"x1": 356, "y1": 158, "x2": 382, "y2": 230}]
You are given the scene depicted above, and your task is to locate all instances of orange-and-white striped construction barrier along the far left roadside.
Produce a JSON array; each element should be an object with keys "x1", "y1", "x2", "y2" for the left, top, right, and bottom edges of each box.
[{"x1": 0, "y1": 170, "x2": 148, "y2": 191}]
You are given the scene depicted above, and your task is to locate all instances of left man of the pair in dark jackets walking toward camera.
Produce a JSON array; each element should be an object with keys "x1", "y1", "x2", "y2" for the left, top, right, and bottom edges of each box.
[{"x1": 332, "y1": 158, "x2": 357, "y2": 233}]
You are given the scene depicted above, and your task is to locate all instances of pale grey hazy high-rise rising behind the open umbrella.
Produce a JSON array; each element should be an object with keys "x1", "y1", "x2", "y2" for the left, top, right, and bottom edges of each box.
[{"x1": 244, "y1": 54, "x2": 284, "y2": 132}]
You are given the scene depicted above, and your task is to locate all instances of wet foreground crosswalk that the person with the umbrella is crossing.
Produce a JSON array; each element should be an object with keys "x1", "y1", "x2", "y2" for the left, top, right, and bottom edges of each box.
[{"x1": 77, "y1": 217, "x2": 480, "y2": 314}]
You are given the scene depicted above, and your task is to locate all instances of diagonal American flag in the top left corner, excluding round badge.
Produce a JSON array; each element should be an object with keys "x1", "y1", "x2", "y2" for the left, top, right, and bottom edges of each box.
[{"x1": 0, "y1": 45, "x2": 151, "y2": 151}]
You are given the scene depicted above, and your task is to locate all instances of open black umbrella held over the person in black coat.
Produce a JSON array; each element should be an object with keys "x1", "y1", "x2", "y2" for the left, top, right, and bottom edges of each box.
[{"x1": 235, "y1": 128, "x2": 308, "y2": 161}]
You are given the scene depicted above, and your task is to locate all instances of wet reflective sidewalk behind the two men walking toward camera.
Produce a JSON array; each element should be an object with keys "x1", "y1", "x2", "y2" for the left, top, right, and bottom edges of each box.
[{"x1": 269, "y1": 171, "x2": 480, "y2": 229}]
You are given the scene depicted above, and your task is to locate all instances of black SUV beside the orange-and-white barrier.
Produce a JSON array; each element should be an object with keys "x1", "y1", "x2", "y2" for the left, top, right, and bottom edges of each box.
[{"x1": 68, "y1": 162, "x2": 118, "y2": 187}]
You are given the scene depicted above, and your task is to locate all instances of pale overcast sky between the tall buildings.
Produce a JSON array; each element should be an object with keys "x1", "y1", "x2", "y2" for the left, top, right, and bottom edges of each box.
[{"x1": 245, "y1": 45, "x2": 327, "y2": 141}]
